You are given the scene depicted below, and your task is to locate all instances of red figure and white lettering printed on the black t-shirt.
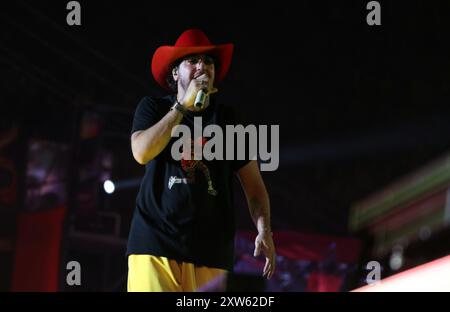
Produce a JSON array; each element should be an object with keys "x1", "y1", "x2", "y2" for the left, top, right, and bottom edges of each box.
[{"x1": 177, "y1": 137, "x2": 218, "y2": 196}]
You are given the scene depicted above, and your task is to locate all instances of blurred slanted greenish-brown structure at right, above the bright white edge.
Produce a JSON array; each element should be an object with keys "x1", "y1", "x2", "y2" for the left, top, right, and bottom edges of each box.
[{"x1": 350, "y1": 154, "x2": 450, "y2": 260}]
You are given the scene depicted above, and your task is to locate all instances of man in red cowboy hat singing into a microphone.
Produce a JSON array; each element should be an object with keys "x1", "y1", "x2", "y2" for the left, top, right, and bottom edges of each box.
[{"x1": 127, "y1": 29, "x2": 275, "y2": 291}]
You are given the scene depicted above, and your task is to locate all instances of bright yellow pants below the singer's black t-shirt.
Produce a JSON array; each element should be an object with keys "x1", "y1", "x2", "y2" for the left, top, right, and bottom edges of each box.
[{"x1": 128, "y1": 255, "x2": 227, "y2": 292}]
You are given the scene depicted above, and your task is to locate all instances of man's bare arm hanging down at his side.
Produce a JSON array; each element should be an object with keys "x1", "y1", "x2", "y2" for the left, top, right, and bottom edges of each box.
[{"x1": 238, "y1": 160, "x2": 275, "y2": 279}]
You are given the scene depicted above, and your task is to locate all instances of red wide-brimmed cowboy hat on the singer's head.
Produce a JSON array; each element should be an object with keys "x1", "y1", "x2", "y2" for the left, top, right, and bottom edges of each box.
[{"x1": 152, "y1": 29, "x2": 233, "y2": 90}]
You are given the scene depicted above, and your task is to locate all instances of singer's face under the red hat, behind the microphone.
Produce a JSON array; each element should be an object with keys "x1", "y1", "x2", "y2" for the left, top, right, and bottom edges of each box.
[{"x1": 174, "y1": 54, "x2": 215, "y2": 91}]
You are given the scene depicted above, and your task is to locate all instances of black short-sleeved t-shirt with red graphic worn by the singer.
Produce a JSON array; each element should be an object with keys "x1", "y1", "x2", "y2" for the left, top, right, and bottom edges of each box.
[{"x1": 127, "y1": 95, "x2": 249, "y2": 270}]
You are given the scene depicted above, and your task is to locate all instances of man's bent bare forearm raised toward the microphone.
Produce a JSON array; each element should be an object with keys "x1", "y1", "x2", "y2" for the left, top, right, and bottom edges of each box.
[{"x1": 131, "y1": 109, "x2": 183, "y2": 165}]
